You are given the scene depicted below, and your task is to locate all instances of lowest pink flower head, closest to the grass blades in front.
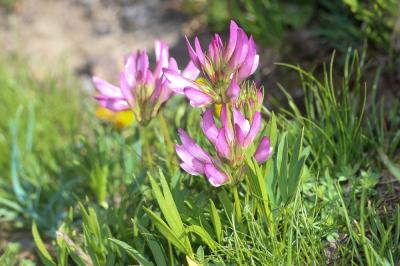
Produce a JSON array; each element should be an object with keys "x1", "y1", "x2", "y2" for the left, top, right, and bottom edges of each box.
[{"x1": 176, "y1": 105, "x2": 272, "y2": 186}]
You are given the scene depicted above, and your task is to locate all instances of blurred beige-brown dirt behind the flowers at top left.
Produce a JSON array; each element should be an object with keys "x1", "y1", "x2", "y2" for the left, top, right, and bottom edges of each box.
[{"x1": 0, "y1": 0, "x2": 188, "y2": 82}]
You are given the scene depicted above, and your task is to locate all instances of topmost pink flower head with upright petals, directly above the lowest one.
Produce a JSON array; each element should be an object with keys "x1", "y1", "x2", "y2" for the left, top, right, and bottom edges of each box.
[{"x1": 165, "y1": 21, "x2": 259, "y2": 107}]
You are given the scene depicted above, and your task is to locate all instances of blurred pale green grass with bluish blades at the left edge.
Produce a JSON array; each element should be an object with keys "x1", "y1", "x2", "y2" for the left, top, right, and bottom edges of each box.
[{"x1": 0, "y1": 54, "x2": 82, "y2": 232}]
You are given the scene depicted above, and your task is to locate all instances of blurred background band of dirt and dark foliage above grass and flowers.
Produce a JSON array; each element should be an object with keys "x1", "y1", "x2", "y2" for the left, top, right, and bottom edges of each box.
[{"x1": 0, "y1": 0, "x2": 400, "y2": 95}]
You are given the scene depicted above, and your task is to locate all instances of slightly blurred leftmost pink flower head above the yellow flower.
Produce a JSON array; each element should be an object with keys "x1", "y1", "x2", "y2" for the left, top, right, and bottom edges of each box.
[{"x1": 93, "y1": 41, "x2": 199, "y2": 125}]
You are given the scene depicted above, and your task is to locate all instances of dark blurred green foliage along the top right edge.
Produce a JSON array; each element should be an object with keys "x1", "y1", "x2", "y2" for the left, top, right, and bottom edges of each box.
[{"x1": 183, "y1": 0, "x2": 400, "y2": 53}]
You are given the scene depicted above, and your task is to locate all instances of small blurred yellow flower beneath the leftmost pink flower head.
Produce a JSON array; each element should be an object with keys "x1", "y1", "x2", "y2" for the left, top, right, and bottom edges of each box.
[{"x1": 96, "y1": 107, "x2": 135, "y2": 129}]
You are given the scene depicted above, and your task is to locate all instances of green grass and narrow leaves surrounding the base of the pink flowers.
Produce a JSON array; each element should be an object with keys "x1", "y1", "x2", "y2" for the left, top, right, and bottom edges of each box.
[{"x1": 0, "y1": 46, "x2": 400, "y2": 265}]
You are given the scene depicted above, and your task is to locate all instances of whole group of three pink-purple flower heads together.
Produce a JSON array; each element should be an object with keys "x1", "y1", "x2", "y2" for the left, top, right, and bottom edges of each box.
[{"x1": 93, "y1": 21, "x2": 272, "y2": 187}]
